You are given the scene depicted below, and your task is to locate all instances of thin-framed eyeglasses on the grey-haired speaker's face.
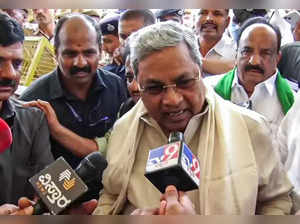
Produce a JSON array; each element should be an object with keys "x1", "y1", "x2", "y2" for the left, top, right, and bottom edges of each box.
[{"x1": 138, "y1": 70, "x2": 201, "y2": 95}]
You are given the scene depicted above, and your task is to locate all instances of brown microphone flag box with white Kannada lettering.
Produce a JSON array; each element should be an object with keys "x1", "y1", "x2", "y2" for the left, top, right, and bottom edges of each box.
[{"x1": 29, "y1": 157, "x2": 88, "y2": 215}]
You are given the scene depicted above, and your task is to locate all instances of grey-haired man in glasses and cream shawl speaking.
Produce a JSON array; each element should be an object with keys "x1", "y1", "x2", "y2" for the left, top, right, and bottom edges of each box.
[{"x1": 94, "y1": 22, "x2": 292, "y2": 215}]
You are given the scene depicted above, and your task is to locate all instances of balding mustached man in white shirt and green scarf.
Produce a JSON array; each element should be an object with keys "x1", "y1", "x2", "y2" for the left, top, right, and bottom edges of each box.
[{"x1": 208, "y1": 17, "x2": 294, "y2": 134}]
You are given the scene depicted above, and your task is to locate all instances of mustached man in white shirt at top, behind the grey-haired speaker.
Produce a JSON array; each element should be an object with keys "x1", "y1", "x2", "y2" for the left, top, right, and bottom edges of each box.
[{"x1": 196, "y1": 9, "x2": 236, "y2": 76}]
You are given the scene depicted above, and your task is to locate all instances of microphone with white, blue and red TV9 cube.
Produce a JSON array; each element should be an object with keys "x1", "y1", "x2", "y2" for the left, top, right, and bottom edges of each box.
[{"x1": 145, "y1": 132, "x2": 200, "y2": 193}]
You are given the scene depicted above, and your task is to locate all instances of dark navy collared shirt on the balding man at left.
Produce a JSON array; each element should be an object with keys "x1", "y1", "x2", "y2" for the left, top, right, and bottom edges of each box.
[{"x1": 20, "y1": 69, "x2": 125, "y2": 168}]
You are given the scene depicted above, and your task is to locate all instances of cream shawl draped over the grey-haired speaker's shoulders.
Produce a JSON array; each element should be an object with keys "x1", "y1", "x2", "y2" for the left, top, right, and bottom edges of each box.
[{"x1": 94, "y1": 87, "x2": 291, "y2": 215}]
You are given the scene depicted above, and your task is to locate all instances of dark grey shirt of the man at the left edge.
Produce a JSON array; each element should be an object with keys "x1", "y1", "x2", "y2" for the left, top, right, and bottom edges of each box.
[{"x1": 0, "y1": 98, "x2": 53, "y2": 205}]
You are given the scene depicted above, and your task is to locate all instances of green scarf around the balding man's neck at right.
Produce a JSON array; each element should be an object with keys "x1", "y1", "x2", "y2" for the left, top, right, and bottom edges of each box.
[{"x1": 215, "y1": 67, "x2": 294, "y2": 114}]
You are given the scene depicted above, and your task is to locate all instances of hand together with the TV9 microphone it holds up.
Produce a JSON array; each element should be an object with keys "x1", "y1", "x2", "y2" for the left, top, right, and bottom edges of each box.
[{"x1": 132, "y1": 132, "x2": 200, "y2": 215}]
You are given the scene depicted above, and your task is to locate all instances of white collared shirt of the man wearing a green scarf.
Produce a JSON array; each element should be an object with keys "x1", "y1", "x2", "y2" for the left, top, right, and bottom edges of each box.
[{"x1": 231, "y1": 71, "x2": 284, "y2": 134}]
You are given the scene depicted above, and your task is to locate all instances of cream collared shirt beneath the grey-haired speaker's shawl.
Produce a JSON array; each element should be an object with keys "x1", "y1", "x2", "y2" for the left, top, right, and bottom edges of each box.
[{"x1": 124, "y1": 105, "x2": 208, "y2": 214}]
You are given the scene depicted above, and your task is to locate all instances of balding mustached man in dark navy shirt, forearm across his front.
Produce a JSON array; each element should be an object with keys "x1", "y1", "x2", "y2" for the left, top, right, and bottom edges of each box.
[{"x1": 20, "y1": 14, "x2": 125, "y2": 178}]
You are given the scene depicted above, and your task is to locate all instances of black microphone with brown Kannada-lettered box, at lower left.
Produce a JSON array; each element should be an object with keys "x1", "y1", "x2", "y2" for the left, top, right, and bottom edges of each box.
[{"x1": 29, "y1": 152, "x2": 107, "y2": 215}]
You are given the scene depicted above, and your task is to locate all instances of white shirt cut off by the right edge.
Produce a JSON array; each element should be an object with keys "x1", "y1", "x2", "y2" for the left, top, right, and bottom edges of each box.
[{"x1": 278, "y1": 92, "x2": 300, "y2": 194}]
